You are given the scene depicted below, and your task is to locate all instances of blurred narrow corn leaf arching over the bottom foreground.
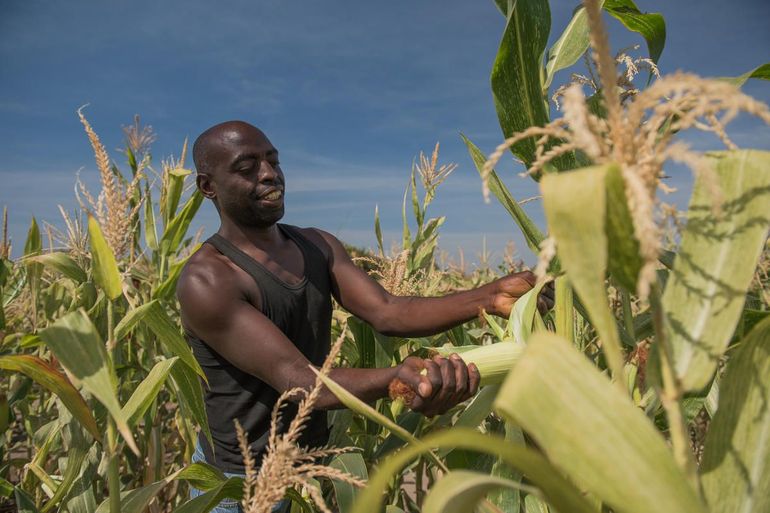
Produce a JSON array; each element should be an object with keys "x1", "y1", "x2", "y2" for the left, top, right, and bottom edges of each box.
[{"x1": 353, "y1": 428, "x2": 597, "y2": 513}]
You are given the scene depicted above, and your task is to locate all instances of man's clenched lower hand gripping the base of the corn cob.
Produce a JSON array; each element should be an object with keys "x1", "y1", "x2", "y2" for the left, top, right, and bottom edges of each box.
[{"x1": 396, "y1": 353, "x2": 481, "y2": 417}]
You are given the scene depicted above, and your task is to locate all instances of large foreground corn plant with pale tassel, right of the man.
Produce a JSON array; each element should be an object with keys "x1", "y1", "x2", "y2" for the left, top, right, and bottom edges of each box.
[{"x1": 320, "y1": 1, "x2": 770, "y2": 512}]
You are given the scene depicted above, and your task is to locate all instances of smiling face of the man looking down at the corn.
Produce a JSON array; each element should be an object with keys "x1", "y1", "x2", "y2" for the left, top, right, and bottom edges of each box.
[{"x1": 199, "y1": 124, "x2": 284, "y2": 228}]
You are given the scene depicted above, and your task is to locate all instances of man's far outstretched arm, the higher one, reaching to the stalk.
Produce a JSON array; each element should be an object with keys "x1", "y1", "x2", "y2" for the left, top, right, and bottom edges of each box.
[{"x1": 304, "y1": 230, "x2": 553, "y2": 337}]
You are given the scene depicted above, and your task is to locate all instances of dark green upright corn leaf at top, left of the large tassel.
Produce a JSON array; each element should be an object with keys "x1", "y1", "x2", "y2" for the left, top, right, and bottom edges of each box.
[{"x1": 490, "y1": 0, "x2": 551, "y2": 167}]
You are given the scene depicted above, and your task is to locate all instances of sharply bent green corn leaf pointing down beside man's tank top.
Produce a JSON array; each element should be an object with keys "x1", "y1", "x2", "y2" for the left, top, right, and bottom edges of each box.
[{"x1": 115, "y1": 299, "x2": 206, "y2": 380}]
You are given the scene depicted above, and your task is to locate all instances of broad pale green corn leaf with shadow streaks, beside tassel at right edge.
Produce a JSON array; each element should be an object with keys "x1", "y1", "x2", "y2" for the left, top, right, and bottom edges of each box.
[{"x1": 663, "y1": 150, "x2": 770, "y2": 390}]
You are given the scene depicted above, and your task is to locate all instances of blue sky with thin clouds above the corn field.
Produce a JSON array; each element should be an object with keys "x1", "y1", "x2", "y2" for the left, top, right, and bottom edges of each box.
[{"x1": 0, "y1": 0, "x2": 770, "y2": 268}]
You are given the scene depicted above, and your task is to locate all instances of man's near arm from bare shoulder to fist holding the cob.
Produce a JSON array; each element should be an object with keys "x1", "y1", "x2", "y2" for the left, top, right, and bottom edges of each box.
[{"x1": 177, "y1": 264, "x2": 478, "y2": 415}]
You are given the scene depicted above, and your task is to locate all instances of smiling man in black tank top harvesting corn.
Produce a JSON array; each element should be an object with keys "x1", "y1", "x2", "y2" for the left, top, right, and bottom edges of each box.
[{"x1": 177, "y1": 121, "x2": 552, "y2": 508}]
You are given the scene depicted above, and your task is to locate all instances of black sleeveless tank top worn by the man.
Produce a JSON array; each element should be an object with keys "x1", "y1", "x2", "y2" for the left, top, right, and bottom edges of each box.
[{"x1": 186, "y1": 224, "x2": 332, "y2": 473}]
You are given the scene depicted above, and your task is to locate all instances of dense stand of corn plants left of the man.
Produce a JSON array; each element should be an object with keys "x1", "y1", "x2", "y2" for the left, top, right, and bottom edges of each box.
[{"x1": 0, "y1": 116, "x2": 246, "y2": 513}]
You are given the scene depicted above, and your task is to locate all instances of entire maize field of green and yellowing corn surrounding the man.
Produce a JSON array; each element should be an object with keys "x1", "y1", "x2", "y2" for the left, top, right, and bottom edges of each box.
[{"x1": 0, "y1": 0, "x2": 770, "y2": 513}]
